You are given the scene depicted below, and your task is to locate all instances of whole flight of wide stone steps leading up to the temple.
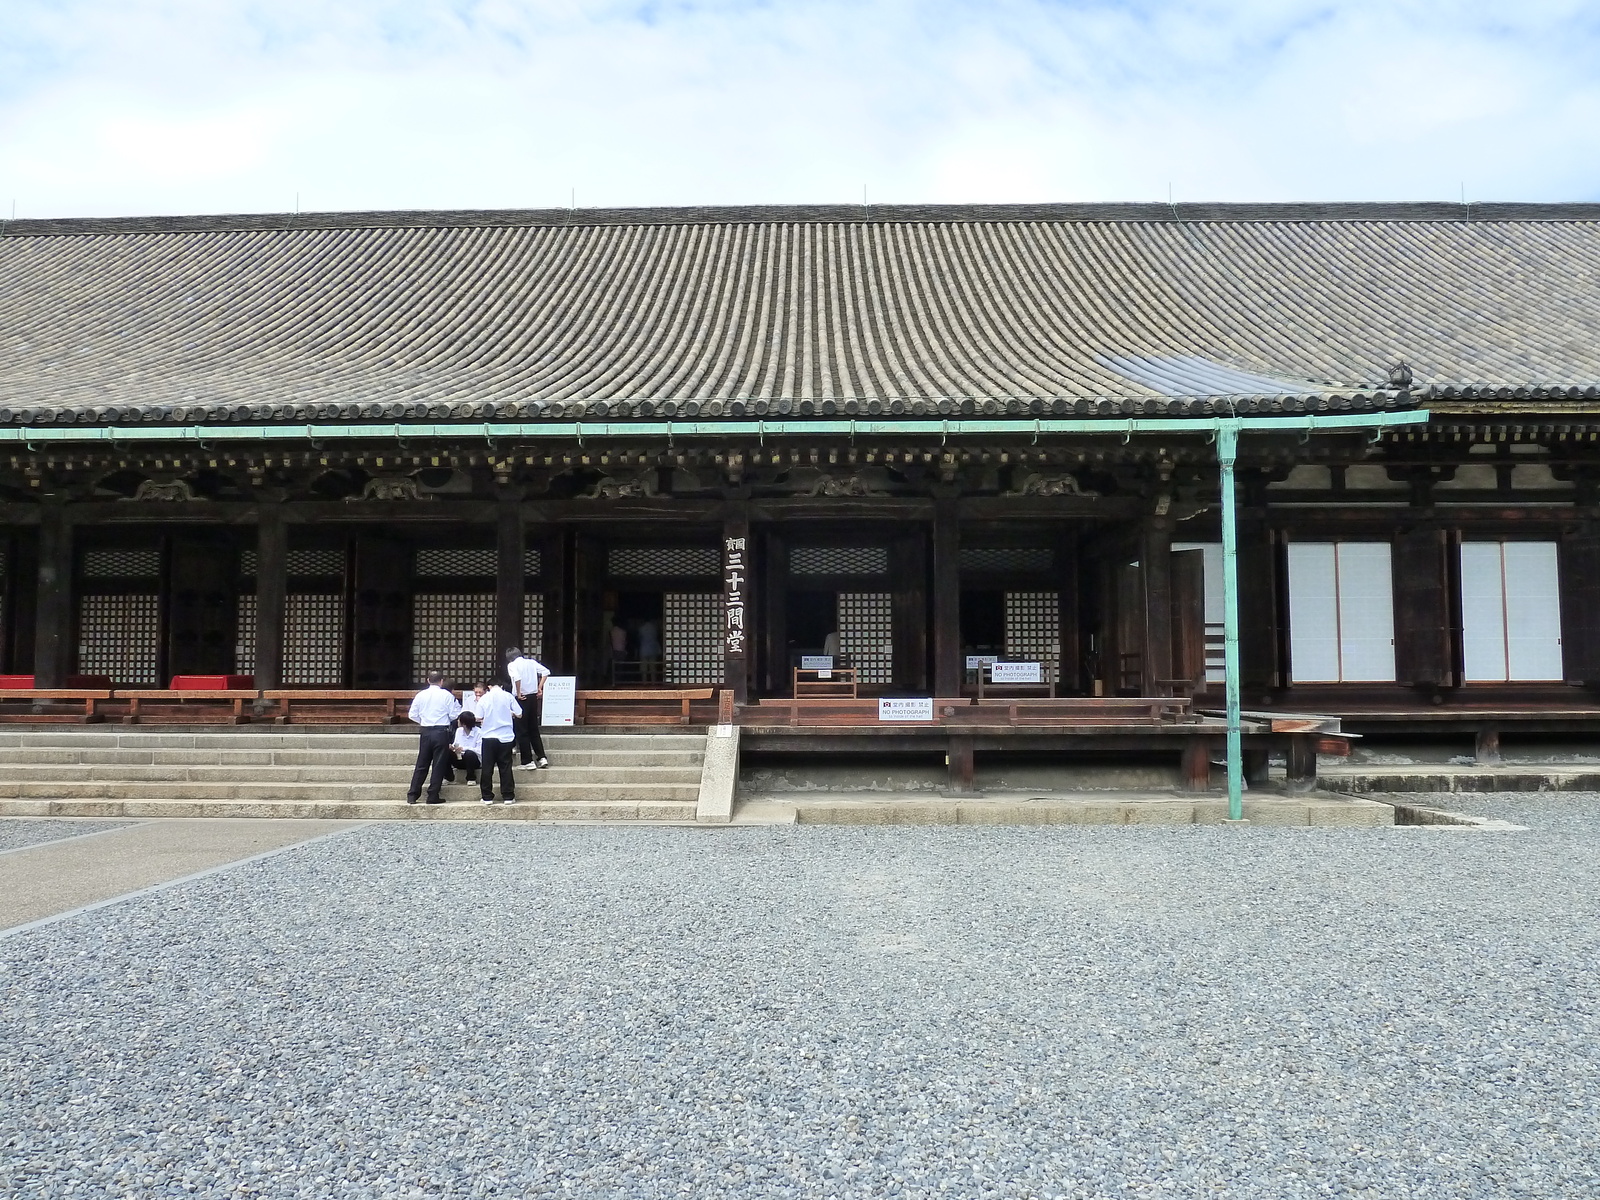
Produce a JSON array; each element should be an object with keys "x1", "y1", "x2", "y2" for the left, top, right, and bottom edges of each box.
[{"x1": 0, "y1": 728, "x2": 706, "y2": 821}]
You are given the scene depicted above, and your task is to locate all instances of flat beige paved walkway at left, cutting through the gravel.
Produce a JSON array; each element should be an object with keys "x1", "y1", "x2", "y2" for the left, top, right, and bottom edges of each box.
[{"x1": 0, "y1": 818, "x2": 350, "y2": 931}]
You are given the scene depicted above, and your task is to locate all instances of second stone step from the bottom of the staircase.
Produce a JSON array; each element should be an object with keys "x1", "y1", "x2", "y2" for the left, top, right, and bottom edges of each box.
[{"x1": 0, "y1": 784, "x2": 699, "y2": 803}]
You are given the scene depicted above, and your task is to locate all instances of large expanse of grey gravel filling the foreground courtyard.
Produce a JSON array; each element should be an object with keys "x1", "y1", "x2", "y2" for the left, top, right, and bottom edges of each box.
[{"x1": 0, "y1": 795, "x2": 1600, "y2": 1200}]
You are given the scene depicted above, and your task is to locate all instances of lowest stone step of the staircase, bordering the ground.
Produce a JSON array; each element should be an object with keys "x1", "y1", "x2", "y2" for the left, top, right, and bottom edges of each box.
[{"x1": 0, "y1": 797, "x2": 694, "y2": 824}]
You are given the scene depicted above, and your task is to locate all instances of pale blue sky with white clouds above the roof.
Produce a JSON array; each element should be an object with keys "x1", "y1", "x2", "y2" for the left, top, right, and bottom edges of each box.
[{"x1": 0, "y1": 0, "x2": 1600, "y2": 219}]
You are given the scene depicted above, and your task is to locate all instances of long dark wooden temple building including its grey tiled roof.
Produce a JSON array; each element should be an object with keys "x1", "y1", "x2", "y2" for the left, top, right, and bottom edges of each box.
[{"x1": 0, "y1": 205, "x2": 1600, "y2": 739}]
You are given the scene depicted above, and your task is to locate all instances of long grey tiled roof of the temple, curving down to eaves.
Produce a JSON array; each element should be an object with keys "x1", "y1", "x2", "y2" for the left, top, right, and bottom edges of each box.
[{"x1": 0, "y1": 205, "x2": 1600, "y2": 422}]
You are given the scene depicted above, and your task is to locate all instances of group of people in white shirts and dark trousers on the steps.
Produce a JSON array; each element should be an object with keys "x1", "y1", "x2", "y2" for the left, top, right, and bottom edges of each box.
[{"x1": 405, "y1": 646, "x2": 550, "y2": 805}]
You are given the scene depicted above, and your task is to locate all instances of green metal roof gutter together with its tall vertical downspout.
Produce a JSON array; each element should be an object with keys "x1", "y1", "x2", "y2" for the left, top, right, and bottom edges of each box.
[{"x1": 0, "y1": 408, "x2": 1427, "y2": 809}]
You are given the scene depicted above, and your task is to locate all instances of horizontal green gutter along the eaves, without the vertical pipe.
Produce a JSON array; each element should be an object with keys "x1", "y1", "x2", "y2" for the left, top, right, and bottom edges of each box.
[{"x1": 0, "y1": 408, "x2": 1427, "y2": 446}]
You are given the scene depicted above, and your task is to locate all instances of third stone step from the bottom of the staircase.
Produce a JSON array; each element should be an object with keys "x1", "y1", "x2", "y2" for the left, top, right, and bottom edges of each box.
[{"x1": 5, "y1": 763, "x2": 701, "y2": 787}]
